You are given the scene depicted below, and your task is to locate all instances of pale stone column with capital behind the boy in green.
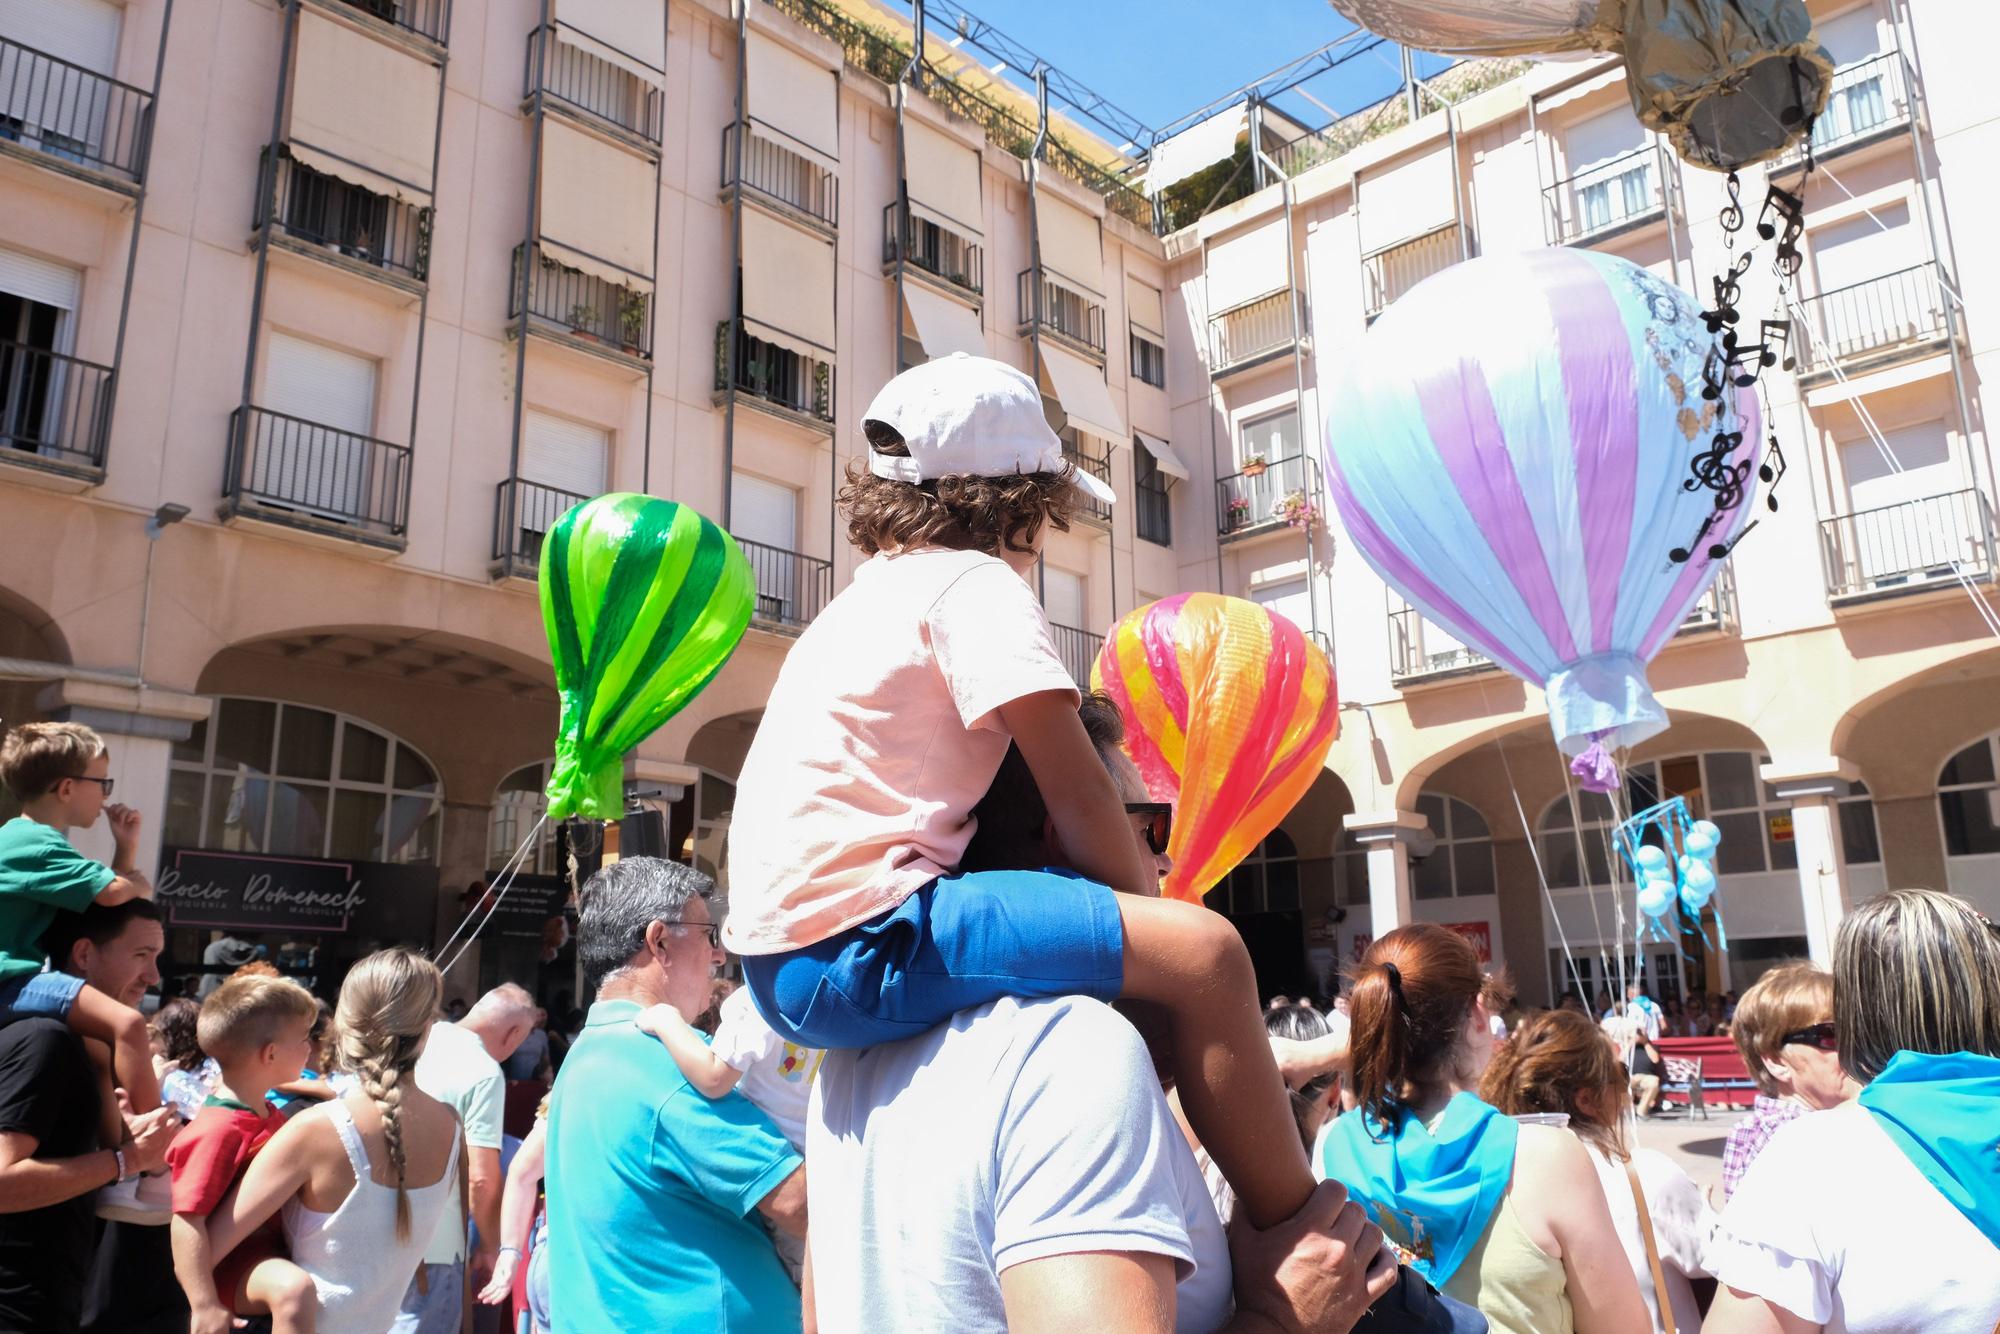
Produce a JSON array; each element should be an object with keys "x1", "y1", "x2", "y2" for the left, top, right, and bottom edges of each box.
[{"x1": 36, "y1": 680, "x2": 214, "y2": 876}]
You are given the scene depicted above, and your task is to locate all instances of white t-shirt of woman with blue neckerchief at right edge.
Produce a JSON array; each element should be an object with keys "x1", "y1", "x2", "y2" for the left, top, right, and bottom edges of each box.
[{"x1": 1714, "y1": 1102, "x2": 2000, "y2": 1334}]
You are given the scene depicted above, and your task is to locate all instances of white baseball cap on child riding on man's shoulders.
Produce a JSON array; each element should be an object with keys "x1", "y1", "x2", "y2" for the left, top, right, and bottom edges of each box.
[{"x1": 862, "y1": 352, "x2": 1118, "y2": 504}]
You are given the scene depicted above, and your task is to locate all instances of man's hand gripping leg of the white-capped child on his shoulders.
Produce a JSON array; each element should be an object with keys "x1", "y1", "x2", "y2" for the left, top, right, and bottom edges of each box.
[{"x1": 1230, "y1": 1182, "x2": 1396, "y2": 1334}]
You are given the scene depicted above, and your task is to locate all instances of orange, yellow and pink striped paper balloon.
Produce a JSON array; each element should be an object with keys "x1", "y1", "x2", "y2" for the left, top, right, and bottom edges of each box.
[{"x1": 1090, "y1": 592, "x2": 1340, "y2": 900}]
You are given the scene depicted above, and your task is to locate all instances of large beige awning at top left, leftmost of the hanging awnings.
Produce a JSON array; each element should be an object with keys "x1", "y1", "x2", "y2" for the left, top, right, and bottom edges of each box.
[{"x1": 286, "y1": 8, "x2": 440, "y2": 204}]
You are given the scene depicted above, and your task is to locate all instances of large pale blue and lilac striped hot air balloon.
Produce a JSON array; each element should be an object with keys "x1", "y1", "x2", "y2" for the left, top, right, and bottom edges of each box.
[{"x1": 1326, "y1": 248, "x2": 1758, "y2": 756}]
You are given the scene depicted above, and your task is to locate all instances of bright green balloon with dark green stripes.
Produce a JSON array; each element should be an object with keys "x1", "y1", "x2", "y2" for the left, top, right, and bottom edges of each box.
[{"x1": 540, "y1": 492, "x2": 756, "y2": 820}]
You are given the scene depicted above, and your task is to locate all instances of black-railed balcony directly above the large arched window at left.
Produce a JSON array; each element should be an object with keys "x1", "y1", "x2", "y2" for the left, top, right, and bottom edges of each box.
[{"x1": 222, "y1": 408, "x2": 410, "y2": 550}]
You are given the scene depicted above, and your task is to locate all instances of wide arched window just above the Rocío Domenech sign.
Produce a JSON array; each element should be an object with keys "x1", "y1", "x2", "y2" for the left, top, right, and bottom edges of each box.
[{"x1": 164, "y1": 698, "x2": 442, "y2": 862}]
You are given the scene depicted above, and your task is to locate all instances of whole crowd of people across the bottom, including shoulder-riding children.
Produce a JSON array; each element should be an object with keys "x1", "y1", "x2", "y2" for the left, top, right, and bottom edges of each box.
[{"x1": 0, "y1": 356, "x2": 2000, "y2": 1334}]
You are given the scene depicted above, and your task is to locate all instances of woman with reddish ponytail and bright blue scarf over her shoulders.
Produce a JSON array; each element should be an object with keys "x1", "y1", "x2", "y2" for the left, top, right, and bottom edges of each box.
[{"x1": 1320, "y1": 924, "x2": 1650, "y2": 1334}]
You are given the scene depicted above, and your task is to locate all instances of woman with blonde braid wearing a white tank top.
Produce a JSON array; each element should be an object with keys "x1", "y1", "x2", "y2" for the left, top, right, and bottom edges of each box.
[{"x1": 208, "y1": 950, "x2": 464, "y2": 1334}]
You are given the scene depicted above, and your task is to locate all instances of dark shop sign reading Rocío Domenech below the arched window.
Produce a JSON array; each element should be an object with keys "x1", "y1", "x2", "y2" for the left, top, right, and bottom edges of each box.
[{"x1": 154, "y1": 848, "x2": 438, "y2": 942}]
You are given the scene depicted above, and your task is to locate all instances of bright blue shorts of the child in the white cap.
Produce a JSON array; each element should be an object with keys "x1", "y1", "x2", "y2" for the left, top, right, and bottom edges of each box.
[{"x1": 744, "y1": 870, "x2": 1124, "y2": 1048}]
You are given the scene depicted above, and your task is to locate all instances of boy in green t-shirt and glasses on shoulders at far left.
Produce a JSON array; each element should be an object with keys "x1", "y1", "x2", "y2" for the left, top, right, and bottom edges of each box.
[{"x1": 0, "y1": 722, "x2": 160, "y2": 1136}]
